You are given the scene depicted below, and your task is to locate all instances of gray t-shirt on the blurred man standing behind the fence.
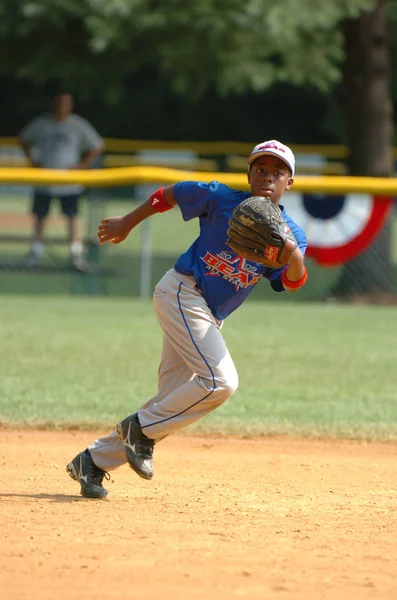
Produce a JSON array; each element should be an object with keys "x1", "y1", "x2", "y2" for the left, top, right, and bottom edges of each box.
[{"x1": 19, "y1": 114, "x2": 103, "y2": 196}]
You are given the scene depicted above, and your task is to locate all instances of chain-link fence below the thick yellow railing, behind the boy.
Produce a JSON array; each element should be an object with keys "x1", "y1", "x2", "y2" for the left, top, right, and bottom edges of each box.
[{"x1": 0, "y1": 186, "x2": 397, "y2": 302}]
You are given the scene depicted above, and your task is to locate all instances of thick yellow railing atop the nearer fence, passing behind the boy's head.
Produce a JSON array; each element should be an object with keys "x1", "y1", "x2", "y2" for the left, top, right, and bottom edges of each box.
[{"x1": 0, "y1": 166, "x2": 397, "y2": 196}]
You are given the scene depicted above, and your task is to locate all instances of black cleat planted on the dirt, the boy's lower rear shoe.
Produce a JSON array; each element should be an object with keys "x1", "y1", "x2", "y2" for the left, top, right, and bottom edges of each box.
[{"x1": 66, "y1": 448, "x2": 110, "y2": 498}]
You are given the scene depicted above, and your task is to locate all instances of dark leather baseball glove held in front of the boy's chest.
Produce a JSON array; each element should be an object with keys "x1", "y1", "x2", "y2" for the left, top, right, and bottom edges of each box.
[{"x1": 227, "y1": 196, "x2": 298, "y2": 269}]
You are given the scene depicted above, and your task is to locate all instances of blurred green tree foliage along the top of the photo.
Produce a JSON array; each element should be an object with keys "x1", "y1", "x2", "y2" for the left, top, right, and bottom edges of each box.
[{"x1": 0, "y1": 0, "x2": 374, "y2": 97}]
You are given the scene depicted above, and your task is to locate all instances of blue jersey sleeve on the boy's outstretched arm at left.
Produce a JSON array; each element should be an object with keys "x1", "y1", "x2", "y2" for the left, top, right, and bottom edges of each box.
[{"x1": 174, "y1": 181, "x2": 217, "y2": 221}]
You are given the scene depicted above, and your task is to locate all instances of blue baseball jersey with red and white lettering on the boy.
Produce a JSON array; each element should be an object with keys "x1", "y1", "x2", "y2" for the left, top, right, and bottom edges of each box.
[{"x1": 174, "y1": 181, "x2": 307, "y2": 320}]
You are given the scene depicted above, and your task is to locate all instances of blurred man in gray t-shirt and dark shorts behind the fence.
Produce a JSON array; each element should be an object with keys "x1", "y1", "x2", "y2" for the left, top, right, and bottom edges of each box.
[{"x1": 19, "y1": 94, "x2": 103, "y2": 271}]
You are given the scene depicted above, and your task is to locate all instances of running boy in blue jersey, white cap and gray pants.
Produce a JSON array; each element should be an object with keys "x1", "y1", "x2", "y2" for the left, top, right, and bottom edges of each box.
[{"x1": 67, "y1": 140, "x2": 307, "y2": 498}]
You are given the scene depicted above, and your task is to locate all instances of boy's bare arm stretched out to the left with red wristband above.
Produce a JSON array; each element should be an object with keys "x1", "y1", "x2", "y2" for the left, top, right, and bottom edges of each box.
[{"x1": 97, "y1": 185, "x2": 176, "y2": 245}]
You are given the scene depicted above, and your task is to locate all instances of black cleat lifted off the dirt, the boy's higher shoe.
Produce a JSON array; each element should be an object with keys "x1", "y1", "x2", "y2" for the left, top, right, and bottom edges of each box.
[{"x1": 116, "y1": 413, "x2": 155, "y2": 479}]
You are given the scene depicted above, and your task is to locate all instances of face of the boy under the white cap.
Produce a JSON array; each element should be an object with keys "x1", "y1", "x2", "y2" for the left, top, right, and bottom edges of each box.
[{"x1": 248, "y1": 155, "x2": 294, "y2": 204}]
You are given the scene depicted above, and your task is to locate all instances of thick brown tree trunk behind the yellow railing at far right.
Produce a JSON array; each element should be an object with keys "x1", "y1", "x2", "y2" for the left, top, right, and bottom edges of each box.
[{"x1": 334, "y1": 0, "x2": 394, "y2": 295}]
